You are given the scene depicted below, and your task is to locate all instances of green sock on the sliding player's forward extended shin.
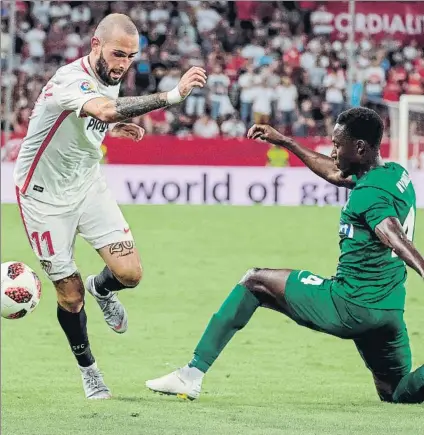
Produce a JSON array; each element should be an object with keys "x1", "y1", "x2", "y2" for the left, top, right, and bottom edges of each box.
[{"x1": 189, "y1": 284, "x2": 260, "y2": 373}]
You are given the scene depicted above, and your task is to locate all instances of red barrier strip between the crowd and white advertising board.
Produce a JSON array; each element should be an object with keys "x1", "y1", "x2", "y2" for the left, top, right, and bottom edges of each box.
[{"x1": 1, "y1": 135, "x2": 412, "y2": 167}]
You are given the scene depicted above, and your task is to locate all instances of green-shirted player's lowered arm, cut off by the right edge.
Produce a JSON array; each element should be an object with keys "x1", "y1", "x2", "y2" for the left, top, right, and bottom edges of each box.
[{"x1": 375, "y1": 217, "x2": 424, "y2": 279}]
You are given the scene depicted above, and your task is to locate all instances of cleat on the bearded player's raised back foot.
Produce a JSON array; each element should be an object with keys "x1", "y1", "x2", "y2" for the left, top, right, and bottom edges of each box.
[{"x1": 85, "y1": 275, "x2": 128, "y2": 334}]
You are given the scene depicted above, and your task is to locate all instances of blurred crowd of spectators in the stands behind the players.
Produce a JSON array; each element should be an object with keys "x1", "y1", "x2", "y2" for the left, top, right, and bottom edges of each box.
[{"x1": 0, "y1": 0, "x2": 424, "y2": 138}]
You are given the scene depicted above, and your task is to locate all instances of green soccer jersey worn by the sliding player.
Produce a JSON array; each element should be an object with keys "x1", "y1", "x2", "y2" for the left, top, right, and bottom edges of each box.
[{"x1": 333, "y1": 163, "x2": 416, "y2": 309}]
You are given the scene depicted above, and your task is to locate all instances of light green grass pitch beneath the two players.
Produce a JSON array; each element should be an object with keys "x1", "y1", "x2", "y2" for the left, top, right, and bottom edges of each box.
[{"x1": 1, "y1": 205, "x2": 424, "y2": 435}]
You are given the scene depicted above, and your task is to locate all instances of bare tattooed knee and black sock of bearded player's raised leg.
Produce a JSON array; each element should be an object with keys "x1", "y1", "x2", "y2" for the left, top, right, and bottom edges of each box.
[{"x1": 94, "y1": 241, "x2": 142, "y2": 296}]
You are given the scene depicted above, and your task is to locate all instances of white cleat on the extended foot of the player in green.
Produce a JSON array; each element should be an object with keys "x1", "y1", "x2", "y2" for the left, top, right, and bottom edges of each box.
[{"x1": 146, "y1": 366, "x2": 204, "y2": 400}]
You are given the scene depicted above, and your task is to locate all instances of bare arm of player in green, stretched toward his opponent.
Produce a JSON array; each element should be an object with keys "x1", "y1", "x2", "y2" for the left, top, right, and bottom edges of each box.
[{"x1": 247, "y1": 124, "x2": 355, "y2": 189}]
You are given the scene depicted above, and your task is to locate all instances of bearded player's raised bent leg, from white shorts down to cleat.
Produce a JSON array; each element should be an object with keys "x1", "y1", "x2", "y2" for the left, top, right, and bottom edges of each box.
[{"x1": 78, "y1": 179, "x2": 142, "y2": 333}]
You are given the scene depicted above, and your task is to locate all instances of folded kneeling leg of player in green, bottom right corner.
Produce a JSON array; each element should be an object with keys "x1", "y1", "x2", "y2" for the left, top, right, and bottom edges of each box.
[{"x1": 355, "y1": 310, "x2": 424, "y2": 403}]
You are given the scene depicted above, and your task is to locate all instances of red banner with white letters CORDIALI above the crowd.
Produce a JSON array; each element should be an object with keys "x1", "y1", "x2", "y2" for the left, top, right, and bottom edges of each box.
[{"x1": 326, "y1": 1, "x2": 424, "y2": 42}]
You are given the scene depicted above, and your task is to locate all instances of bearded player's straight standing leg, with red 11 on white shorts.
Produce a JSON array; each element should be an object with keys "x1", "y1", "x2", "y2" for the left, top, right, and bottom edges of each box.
[{"x1": 18, "y1": 189, "x2": 110, "y2": 399}]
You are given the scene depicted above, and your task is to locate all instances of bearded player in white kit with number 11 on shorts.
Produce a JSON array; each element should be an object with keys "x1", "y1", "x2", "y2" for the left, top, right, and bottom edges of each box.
[{"x1": 14, "y1": 14, "x2": 206, "y2": 399}]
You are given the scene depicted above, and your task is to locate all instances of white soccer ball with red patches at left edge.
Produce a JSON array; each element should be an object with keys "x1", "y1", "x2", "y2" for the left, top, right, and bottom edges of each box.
[{"x1": 1, "y1": 261, "x2": 41, "y2": 319}]
